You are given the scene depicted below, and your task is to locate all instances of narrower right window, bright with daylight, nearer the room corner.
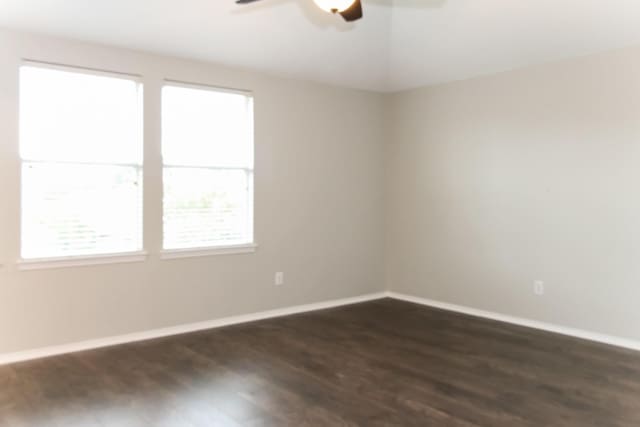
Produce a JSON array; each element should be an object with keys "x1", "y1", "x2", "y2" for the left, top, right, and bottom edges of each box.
[{"x1": 162, "y1": 84, "x2": 253, "y2": 250}]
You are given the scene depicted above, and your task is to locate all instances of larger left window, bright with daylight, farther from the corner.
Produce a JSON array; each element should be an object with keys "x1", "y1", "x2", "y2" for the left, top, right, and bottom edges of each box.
[{"x1": 20, "y1": 65, "x2": 143, "y2": 260}]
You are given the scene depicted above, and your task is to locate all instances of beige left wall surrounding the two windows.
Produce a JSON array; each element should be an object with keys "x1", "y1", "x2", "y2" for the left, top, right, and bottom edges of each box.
[{"x1": 0, "y1": 28, "x2": 384, "y2": 354}]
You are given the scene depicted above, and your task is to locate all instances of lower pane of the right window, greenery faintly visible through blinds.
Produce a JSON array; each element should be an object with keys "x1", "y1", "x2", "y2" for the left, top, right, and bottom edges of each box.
[{"x1": 164, "y1": 167, "x2": 253, "y2": 249}]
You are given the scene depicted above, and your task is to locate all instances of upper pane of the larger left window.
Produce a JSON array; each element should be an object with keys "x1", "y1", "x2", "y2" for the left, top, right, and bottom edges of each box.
[{"x1": 20, "y1": 66, "x2": 142, "y2": 164}]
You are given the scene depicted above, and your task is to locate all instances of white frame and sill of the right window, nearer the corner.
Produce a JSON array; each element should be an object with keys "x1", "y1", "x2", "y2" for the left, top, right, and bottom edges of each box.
[{"x1": 160, "y1": 79, "x2": 258, "y2": 260}]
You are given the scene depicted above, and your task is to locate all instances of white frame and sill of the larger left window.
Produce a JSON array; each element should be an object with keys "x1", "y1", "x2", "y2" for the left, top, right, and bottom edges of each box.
[{"x1": 16, "y1": 59, "x2": 149, "y2": 270}]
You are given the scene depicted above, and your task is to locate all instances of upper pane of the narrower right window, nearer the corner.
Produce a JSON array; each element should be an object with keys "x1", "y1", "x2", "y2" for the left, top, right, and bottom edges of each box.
[{"x1": 162, "y1": 86, "x2": 253, "y2": 168}]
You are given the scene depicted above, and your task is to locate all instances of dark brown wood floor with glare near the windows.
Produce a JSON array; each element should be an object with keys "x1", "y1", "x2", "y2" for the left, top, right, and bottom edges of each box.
[{"x1": 0, "y1": 300, "x2": 640, "y2": 427}]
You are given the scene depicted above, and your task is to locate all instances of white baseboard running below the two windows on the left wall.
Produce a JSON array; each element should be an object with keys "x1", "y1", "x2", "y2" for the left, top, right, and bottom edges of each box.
[{"x1": 0, "y1": 292, "x2": 387, "y2": 365}]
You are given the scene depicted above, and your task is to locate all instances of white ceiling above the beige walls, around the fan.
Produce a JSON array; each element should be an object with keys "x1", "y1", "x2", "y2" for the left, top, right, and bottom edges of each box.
[{"x1": 0, "y1": 0, "x2": 640, "y2": 91}]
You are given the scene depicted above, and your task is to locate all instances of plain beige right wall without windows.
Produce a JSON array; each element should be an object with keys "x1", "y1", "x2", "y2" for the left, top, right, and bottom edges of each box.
[{"x1": 386, "y1": 48, "x2": 640, "y2": 339}]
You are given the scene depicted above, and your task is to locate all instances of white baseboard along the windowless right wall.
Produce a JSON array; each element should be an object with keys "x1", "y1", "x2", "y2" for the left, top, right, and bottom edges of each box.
[{"x1": 386, "y1": 292, "x2": 640, "y2": 351}]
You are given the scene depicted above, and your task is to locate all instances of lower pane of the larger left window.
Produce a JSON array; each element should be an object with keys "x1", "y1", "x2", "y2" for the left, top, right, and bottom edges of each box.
[{"x1": 22, "y1": 162, "x2": 142, "y2": 259}]
